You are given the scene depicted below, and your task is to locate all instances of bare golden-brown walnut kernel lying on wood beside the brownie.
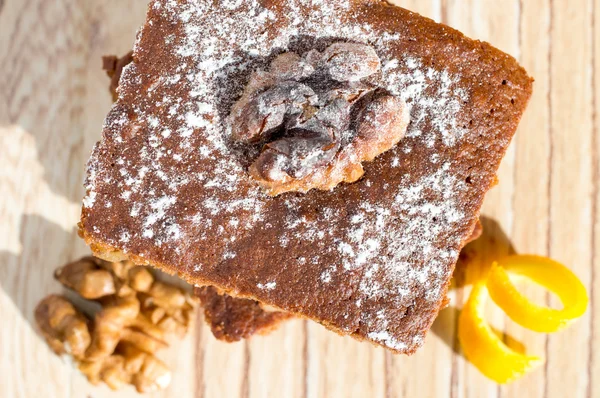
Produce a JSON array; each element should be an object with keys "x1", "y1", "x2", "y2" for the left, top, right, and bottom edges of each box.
[{"x1": 35, "y1": 257, "x2": 195, "y2": 392}]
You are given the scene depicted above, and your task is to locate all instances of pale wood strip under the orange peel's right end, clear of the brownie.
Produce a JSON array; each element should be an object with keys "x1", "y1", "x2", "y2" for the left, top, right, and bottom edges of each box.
[{"x1": 546, "y1": 0, "x2": 593, "y2": 397}]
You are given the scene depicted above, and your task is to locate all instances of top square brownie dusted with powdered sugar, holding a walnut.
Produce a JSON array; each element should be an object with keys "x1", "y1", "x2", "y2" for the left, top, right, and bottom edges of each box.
[{"x1": 80, "y1": 0, "x2": 532, "y2": 353}]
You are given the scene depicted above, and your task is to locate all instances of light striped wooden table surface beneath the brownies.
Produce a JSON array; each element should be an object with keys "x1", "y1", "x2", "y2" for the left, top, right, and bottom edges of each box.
[{"x1": 0, "y1": 0, "x2": 600, "y2": 398}]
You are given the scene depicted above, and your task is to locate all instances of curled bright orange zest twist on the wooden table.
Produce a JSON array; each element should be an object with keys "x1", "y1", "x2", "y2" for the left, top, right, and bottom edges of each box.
[{"x1": 458, "y1": 255, "x2": 588, "y2": 383}]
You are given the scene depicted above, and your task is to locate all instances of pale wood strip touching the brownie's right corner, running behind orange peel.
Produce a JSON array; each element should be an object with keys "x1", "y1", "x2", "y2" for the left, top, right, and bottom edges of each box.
[{"x1": 501, "y1": 0, "x2": 550, "y2": 398}]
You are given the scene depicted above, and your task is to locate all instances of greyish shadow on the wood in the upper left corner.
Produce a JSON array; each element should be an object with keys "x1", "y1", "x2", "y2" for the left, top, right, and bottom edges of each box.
[{"x1": 0, "y1": 0, "x2": 147, "y2": 202}]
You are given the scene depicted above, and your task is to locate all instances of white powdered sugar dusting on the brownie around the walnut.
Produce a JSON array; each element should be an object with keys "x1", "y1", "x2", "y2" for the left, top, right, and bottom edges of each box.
[{"x1": 84, "y1": 0, "x2": 480, "y2": 351}]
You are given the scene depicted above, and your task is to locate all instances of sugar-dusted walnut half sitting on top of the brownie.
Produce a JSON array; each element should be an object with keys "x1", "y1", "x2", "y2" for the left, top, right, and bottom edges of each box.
[{"x1": 229, "y1": 42, "x2": 409, "y2": 196}]
